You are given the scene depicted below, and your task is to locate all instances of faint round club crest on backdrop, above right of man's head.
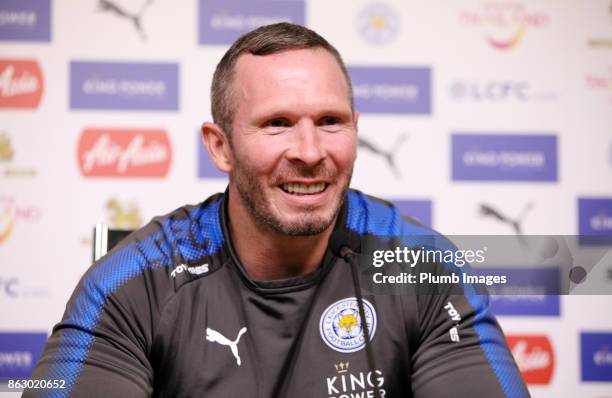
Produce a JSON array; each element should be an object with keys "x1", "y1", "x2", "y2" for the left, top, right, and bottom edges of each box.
[{"x1": 356, "y1": 3, "x2": 400, "y2": 45}]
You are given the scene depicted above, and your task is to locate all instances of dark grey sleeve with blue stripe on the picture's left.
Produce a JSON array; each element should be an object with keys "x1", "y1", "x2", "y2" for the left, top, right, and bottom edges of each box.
[{"x1": 23, "y1": 229, "x2": 167, "y2": 398}]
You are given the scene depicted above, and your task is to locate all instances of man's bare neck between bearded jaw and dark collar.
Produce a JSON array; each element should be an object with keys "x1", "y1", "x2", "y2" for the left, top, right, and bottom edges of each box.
[{"x1": 228, "y1": 189, "x2": 335, "y2": 280}]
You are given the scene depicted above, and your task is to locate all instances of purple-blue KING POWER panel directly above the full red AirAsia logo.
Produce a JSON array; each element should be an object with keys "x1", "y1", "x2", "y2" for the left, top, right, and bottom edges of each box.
[{"x1": 70, "y1": 61, "x2": 179, "y2": 110}]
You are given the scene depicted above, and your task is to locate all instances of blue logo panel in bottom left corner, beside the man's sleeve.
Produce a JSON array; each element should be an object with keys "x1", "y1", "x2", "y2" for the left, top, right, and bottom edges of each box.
[{"x1": 0, "y1": 333, "x2": 47, "y2": 380}]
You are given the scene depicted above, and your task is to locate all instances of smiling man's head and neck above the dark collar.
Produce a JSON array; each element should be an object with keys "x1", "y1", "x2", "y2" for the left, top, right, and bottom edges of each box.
[{"x1": 203, "y1": 36, "x2": 357, "y2": 279}]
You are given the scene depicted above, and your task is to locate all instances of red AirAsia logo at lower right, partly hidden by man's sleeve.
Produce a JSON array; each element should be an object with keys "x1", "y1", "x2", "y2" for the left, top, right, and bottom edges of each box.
[{"x1": 506, "y1": 335, "x2": 555, "y2": 384}]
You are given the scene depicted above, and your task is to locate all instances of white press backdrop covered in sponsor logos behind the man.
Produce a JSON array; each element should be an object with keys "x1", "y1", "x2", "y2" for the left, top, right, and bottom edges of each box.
[{"x1": 0, "y1": 0, "x2": 612, "y2": 398}]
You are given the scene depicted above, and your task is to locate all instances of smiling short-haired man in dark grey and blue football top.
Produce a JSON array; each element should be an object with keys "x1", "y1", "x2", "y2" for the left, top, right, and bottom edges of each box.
[{"x1": 25, "y1": 23, "x2": 528, "y2": 398}]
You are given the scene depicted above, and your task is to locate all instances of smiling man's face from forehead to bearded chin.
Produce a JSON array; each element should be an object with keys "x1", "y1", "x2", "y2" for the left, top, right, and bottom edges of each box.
[{"x1": 230, "y1": 48, "x2": 357, "y2": 236}]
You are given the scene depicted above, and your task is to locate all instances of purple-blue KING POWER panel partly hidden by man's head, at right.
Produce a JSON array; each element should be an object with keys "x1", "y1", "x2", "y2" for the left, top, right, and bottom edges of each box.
[{"x1": 348, "y1": 66, "x2": 431, "y2": 114}]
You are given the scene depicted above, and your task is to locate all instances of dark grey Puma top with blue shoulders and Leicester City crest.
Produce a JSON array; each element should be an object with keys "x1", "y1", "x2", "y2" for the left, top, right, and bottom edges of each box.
[{"x1": 23, "y1": 190, "x2": 529, "y2": 398}]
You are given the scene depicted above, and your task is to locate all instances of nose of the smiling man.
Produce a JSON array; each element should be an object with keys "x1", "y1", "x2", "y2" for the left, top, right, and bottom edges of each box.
[{"x1": 287, "y1": 121, "x2": 326, "y2": 166}]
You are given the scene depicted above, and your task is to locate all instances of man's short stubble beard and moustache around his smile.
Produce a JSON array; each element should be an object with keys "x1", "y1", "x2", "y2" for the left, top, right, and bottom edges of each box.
[{"x1": 230, "y1": 155, "x2": 353, "y2": 236}]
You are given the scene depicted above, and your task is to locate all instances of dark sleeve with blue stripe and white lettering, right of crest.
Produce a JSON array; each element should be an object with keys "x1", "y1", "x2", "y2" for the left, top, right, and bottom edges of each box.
[{"x1": 412, "y1": 266, "x2": 530, "y2": 398}]
